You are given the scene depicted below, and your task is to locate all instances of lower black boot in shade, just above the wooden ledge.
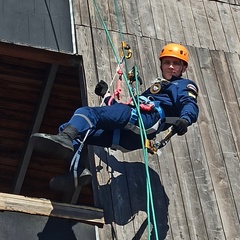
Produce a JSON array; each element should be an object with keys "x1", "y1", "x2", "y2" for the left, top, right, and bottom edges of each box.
[{"x1": 49, "y1": 168, "x2": 92, "y2": 192}]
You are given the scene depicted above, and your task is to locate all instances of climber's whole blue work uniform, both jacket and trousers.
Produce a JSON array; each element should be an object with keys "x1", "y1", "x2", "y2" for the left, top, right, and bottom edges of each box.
[{"x1": 60, "y1": 78, "x2": 199, "y2": 151}]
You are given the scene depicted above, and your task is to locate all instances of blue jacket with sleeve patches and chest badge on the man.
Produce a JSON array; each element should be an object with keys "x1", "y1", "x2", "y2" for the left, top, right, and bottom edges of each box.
[{"x1": 141, "y1": 78, "x2": 199, "y2": 125}]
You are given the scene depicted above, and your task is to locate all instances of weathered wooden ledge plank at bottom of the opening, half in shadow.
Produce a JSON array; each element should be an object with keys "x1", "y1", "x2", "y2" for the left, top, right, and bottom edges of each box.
[{"x1": 0, "y1": 193, "x2": 104, "y2": 226}]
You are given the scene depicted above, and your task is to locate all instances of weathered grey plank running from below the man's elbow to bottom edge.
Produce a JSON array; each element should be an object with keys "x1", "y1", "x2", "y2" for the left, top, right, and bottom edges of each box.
[{"x1": 187, "y1": 125, "x2": 225, "y2": 240}]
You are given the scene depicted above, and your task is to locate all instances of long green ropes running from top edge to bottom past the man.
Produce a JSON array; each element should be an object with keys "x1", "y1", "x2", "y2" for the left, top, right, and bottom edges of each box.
[{"x1": 93, "y1": 0, "x2": 158, "y2": 240}]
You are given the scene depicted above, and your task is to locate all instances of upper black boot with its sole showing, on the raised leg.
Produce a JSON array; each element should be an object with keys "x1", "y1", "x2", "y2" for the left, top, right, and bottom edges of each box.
[{"x1": 30, "y1": 125, "x2": 78, "y2": 159}]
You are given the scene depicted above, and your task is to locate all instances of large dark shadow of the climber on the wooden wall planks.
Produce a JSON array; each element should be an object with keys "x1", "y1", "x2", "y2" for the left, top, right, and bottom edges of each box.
[{"x1": 94, "y1": 150, "x2": 169, "y2": 240}]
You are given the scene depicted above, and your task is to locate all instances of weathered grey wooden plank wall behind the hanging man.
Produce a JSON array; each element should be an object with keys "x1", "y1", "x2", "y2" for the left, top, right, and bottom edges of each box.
[{"x1": 73, "y1": 0, "x2": 240, "y2": 240}]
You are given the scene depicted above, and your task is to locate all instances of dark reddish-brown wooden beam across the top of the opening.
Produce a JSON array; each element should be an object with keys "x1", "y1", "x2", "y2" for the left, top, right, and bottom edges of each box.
[{"x1": 0, "y1": 41, "x2": 82, "y2": 67}]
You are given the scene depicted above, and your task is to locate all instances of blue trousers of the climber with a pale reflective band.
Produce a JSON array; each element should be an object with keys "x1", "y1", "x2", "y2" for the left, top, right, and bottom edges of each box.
[{"x1": 60, "y1": 103, "x2": 160, "y2": 151}]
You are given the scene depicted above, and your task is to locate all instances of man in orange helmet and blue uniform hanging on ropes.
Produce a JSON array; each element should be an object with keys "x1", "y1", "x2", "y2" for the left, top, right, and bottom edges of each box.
[{"x1": 31, "y1": 43, "x2": 199, "y2": 189}]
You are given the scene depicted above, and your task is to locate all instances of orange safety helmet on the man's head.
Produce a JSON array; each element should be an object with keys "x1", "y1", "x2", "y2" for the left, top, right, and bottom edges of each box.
[{"x1": 159, "y1": 43, "x2": 188, "y2": 65}]
